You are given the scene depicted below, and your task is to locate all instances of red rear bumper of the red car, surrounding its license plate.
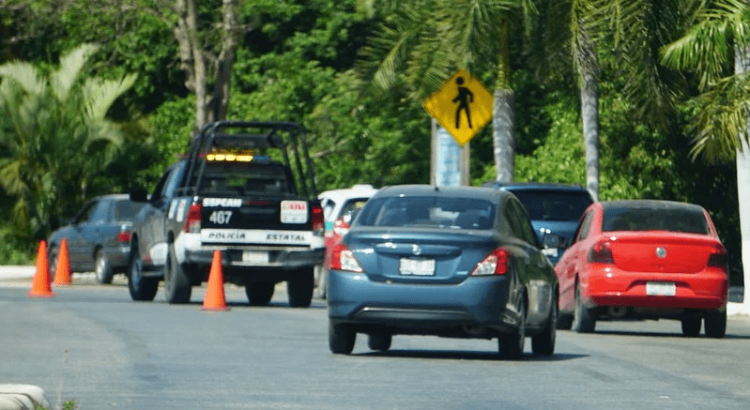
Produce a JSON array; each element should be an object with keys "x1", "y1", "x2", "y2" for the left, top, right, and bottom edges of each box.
[{"x1": 581, "y1": 268, "x2": 729, "y2": 309}]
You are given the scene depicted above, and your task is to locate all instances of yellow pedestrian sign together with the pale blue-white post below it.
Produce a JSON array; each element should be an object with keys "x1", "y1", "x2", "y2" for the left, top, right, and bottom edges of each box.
[{"x1": 424, "y1": 70, "x2": 492, "y2": 186}]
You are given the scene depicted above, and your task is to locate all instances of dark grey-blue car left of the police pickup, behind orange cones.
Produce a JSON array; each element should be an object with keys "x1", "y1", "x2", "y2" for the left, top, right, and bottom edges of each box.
[{"x1": 47, "y1": 194, "x2": 143, "y2": 284}]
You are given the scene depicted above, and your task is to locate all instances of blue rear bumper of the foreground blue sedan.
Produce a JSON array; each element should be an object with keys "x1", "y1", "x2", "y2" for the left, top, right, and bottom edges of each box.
[{"x1": 328, "y1": 270, "x2": 517, "y2": 334}]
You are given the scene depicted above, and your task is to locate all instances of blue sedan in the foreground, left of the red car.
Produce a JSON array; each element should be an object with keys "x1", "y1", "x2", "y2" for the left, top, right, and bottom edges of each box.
[{"x1": 328, "y1": 185, "x2": 558, "y2": 359}]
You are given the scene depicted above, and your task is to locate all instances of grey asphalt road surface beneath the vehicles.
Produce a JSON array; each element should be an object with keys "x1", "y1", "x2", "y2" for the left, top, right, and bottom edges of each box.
[{"x1": 0, "y1": 275, "x2": 750, "y2": 410}]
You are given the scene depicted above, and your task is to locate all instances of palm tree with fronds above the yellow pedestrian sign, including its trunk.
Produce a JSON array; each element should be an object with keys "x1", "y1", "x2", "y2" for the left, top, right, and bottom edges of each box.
[{"x1": 365, "y1": 0, "x2": 535, "y2": 182}]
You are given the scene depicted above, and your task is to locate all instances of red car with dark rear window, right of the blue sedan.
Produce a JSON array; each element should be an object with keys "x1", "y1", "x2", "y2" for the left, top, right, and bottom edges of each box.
[{"x1": 555, "y1": 200, "x2": 729, "y2": 338}]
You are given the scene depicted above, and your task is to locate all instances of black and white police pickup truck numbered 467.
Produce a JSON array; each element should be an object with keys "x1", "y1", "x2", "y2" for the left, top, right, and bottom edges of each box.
[{"x1": 128, "y1": 121, "x2": 325, "y2": 307}]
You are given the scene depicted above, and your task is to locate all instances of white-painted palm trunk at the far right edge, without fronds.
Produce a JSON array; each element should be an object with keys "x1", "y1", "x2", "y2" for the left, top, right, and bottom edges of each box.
[{"x1": 734, "y1": 48, "x2": 750, "y2": 310}]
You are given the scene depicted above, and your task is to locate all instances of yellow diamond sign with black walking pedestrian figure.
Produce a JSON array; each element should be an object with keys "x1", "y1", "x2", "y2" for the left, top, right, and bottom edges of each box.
[{"x1": 424, "y1": 70, "x2": 492, "y2": 146}]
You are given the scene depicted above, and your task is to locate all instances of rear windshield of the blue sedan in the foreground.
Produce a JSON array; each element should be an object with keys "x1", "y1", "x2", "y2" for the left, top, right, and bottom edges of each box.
[{"x1": 357, "y1": 197, "x2": 495, "y2": 229}]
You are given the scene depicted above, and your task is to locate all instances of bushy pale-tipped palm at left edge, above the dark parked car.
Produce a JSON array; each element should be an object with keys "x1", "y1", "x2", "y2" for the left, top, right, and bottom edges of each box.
[{"x1": 0, "y1": 44, "x2": 136, "y2": 243}]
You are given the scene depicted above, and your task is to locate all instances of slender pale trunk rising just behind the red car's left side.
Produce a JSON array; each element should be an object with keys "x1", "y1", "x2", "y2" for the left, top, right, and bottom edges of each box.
[{"x1": 581, "y1": 67, "x2": 599, "y2": 201}]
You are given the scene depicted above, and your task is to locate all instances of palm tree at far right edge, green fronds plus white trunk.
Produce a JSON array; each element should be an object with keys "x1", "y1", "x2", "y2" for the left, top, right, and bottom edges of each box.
[{"x1": 662, "y1": 0, "x2": 750, "y2": 308}]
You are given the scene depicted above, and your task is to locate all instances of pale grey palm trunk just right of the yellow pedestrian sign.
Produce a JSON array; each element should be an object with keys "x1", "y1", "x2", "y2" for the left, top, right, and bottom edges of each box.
[{"x1": 492, "y1": 89, "x2": 516, "y2": 182}]
